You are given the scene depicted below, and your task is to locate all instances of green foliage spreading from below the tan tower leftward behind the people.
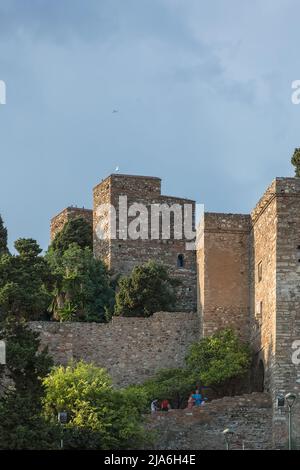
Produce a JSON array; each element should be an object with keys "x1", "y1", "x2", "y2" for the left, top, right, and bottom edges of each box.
[{"x1": 129, "y1": 329, "x2": 251, "y2": 411}]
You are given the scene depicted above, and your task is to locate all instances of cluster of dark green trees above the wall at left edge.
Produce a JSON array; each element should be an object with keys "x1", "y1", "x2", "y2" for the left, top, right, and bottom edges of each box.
[{"x1": 0, "y1": 218, "x2": 115, "y2": 322}]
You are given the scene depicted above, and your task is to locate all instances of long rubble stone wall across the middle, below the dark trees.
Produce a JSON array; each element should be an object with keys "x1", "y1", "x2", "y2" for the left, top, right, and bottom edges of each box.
[{"x1": 30, "y1": 312, "x2": 199, "y2": 385}]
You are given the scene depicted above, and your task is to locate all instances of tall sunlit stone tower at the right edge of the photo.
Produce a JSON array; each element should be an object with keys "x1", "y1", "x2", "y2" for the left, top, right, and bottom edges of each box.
[{"x1": 250, "y1": 178, "x2": 300, "y2": 444}]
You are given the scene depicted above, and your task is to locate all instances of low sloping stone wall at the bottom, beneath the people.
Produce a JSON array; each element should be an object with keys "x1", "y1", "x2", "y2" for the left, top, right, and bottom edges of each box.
[{"x1": 148, "y1": 393, "x2": 272, "y2": 450}]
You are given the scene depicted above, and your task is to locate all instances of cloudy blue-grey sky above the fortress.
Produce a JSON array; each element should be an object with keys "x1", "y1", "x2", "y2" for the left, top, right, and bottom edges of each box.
[{"x1": 0, "y1": 0, "x2": 300, "y2": 252}]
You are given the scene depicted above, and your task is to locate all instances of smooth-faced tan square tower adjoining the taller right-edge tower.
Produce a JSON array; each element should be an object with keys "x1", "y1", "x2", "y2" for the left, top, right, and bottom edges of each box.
[{"x1": 197, "y1": 212, "x2": 250, "y2": 340}]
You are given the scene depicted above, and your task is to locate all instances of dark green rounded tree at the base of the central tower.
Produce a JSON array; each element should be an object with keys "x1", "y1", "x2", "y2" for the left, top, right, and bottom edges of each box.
[{"x1": 115, "y1": 261, "x2": 175, "y2": 317}]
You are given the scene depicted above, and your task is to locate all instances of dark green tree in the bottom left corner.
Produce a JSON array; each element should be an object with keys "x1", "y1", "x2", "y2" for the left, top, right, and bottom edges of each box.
[{"x1": 0, "y1": 318, "x2": 59, "y2": 449}]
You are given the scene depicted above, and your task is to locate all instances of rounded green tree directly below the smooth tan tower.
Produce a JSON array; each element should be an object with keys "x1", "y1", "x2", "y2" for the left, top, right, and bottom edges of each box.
[{"x1": 186, "y1": 329, "x2": 251, "y2": 396}]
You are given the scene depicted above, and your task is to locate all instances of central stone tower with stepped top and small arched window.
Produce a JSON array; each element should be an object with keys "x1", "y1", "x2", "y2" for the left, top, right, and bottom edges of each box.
[{"x1": 93, "y1": 174, "x2": 196, "y2": 311}]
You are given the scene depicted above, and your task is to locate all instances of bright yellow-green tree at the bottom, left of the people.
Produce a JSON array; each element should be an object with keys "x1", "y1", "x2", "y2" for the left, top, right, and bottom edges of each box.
[{"x1": 44, "y1": 362, "x2": 149, "y2": 449}]
